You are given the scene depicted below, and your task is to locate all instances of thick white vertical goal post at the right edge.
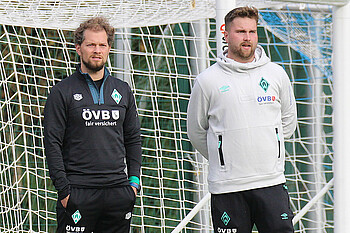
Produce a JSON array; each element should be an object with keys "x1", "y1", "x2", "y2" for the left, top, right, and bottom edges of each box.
[{"x1": 333, "y1": 3, "x2": 350, "y2": 233}]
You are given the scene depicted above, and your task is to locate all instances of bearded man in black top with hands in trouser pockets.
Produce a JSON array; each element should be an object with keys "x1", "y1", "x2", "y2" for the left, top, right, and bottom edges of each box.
[{"x1": 44, "y1": 17, "x2": 141, "y2": 233}]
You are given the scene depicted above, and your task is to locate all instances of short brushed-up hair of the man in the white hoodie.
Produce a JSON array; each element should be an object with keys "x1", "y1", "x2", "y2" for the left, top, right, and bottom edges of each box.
[{"x1": 225, "y1": 6, "x2": 259, "y2": 31}]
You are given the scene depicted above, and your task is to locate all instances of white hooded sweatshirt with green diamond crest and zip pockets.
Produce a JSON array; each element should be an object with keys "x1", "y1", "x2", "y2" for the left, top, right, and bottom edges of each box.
[{"x1": 187, "y1": 45, "x2": 297, "y2": 194}]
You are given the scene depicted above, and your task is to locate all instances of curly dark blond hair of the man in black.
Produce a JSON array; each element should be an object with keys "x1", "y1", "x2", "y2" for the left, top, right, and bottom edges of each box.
[{"x1": 74, "y1": 17, "x2": 115, "y2": 46}]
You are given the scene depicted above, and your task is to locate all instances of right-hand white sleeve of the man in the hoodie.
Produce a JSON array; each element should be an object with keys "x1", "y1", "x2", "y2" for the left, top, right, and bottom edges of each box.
[{"x1": 280, "y1": 73, "x2": 297, "y2": 138}]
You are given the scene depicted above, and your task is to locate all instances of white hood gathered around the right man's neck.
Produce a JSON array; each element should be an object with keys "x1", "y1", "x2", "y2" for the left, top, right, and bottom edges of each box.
[{"x1": 216, "y1": 45, "x2": 270, "y2": 73}]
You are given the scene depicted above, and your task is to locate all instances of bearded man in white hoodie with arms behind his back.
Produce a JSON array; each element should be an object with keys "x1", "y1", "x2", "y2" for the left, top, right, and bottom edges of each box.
[{"x1": 187, "y1": 7, "x2": 297, "y2": 233}]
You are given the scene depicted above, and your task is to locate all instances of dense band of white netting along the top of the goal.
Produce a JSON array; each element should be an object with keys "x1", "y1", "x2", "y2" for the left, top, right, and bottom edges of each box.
[{"x1": 0, "y1": 0, "x2": 304, "y2": 30}]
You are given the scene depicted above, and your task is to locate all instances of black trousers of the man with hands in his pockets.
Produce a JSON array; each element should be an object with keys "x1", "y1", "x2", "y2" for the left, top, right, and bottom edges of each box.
[{"x1": 56, "y1": 186, "x2": 136, "y2": 233}]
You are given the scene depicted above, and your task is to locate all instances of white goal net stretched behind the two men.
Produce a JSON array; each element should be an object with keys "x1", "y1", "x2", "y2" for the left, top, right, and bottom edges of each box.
[{"x1": 0, "y1": 0, "x2": 334, "y2": 233}]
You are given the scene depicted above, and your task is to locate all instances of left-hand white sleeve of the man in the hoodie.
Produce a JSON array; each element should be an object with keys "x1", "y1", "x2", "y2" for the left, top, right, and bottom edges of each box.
[{"x1": 187, "y1": 81, "x2": 209, "y2": 159}]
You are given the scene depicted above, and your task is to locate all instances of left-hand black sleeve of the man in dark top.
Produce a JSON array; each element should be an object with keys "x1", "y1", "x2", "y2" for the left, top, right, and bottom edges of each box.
[{"x1": 44, "y1": 87, "x2": 70, "y2": 200}]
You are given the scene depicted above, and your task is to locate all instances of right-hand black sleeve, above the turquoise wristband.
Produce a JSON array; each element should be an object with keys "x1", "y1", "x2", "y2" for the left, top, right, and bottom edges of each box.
[{"x1": 123, "y1": 86, "x2": 142, "y2": 178}]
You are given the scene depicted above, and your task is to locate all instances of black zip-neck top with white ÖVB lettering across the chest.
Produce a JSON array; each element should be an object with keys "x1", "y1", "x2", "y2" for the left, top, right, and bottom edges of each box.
[{"x1": 44, "y1": 66, "x2": 141, "y2": 200}]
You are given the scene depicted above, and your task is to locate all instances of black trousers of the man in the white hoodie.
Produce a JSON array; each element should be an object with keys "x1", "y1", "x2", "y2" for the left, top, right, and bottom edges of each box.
[{"x1": 211, "y1": 184, "x2": 294, "y2": 233}]
